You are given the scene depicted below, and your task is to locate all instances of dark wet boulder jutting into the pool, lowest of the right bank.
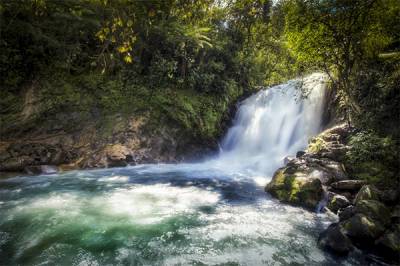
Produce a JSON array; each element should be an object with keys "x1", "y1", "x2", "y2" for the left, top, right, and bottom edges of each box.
[{"x1": 318, "y1": 223, "x2": 353, "y2": 255}]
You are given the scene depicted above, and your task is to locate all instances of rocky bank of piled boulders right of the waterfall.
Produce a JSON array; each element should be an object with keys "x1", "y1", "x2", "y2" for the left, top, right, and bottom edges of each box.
[{"x1": 265, "y1": 124, "x2": 400, "y2": 264}]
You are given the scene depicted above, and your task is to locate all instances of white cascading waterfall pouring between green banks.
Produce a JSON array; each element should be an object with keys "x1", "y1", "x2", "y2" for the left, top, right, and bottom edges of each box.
[{"x1": 212, "y1": 73, "x2": 327, "y2": 175}]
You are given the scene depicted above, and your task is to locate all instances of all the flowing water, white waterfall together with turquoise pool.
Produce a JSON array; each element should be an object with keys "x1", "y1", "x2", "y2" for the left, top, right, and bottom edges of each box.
[{"x1": 0, "y1": 74, "x2": 378, "y2": 265}]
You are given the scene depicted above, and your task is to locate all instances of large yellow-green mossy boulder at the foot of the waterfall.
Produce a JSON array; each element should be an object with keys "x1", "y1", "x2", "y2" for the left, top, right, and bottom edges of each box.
[{"x1": 265, "y1": 168, "x2": 323, "y2": 210}]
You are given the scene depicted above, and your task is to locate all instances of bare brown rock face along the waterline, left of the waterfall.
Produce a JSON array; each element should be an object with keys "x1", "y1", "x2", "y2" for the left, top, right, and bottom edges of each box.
[{"x1": 0, "y1": 115, "x2": 217, "y2": 174}]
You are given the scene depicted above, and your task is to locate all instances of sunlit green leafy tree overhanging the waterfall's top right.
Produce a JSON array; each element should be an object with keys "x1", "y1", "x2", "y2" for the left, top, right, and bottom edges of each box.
[{"x1": 285, "y1": 0, "x2": 398, "y2": 119}]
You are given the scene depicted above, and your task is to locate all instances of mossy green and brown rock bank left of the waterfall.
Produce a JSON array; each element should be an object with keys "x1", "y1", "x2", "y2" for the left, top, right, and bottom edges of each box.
[{"x1": 0, "y1": 75, "x2": 245, "y2": 174}]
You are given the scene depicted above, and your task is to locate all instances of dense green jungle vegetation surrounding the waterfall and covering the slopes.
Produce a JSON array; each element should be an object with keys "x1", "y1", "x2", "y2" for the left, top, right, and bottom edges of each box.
[{"x1": 0, "y1": 0, "x2": 400, "y2": 185}]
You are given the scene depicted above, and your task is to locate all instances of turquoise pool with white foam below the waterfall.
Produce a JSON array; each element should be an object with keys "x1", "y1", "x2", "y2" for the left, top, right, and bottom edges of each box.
[{"x1": 0, "y1": 164, "x2": 378, "y2": 265}]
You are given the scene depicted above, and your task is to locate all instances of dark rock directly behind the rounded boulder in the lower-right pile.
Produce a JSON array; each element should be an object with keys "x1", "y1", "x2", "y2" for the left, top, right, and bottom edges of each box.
[{"x1": 354, "y1": 200, "x2": 390, "y2": 226}]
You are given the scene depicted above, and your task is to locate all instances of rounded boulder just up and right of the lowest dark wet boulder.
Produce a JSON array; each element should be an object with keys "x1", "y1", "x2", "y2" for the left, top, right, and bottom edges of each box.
[{"x1": 341, "y1": 213, "x2": 385, "y2": 241}]
